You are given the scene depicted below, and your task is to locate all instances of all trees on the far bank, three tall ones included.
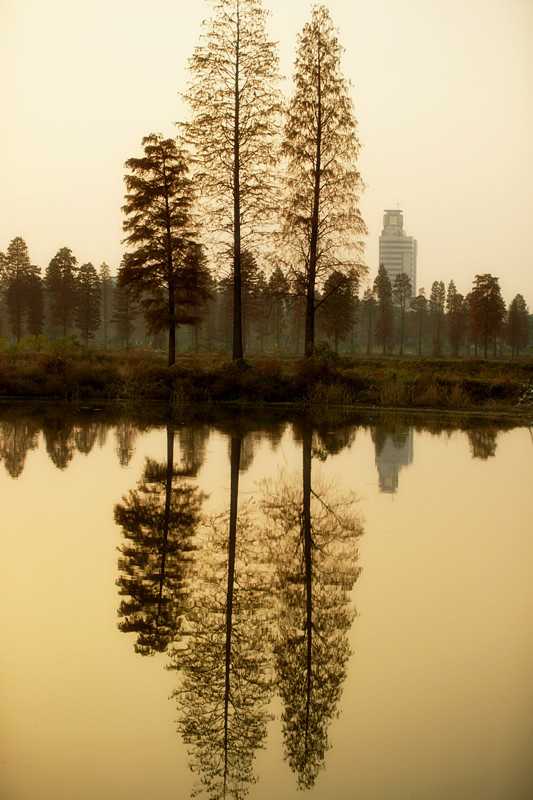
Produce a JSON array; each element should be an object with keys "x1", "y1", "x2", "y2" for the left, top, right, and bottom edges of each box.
[{"x1": 0, "y1": 0, "x2": 528, "y2": 365}]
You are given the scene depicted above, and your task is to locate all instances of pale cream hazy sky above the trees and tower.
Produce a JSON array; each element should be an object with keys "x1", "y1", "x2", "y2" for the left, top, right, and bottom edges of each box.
[{"x1": 0, "y1": 0, "x2": 533, "y2": 310}]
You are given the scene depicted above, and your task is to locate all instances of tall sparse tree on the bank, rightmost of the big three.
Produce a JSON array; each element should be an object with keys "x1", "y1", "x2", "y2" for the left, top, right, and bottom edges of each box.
[{"x1": 283, "y1": 6, "x2": 366, "y2": 356}]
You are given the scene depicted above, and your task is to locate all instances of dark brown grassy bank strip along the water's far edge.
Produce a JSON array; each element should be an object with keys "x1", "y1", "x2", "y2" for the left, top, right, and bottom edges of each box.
[{"x1": 0, "y1": 339, "x2": 533, "y2": 420}]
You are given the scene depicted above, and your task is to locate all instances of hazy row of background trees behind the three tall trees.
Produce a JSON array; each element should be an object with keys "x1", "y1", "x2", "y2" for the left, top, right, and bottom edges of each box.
[{"x1": 0, "y1": 237, "x2": 532, "y2": 358}]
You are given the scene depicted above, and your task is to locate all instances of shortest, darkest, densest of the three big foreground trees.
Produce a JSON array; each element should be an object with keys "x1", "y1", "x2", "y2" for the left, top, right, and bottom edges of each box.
[{"x1": 118, "y1": 133, "x2": 208, "y2": 366}]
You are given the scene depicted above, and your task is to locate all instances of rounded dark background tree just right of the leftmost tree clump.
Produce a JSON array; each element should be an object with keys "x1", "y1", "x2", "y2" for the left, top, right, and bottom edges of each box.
[{"x1": 45, "y1": 247, "x2": 78, "y2": 336}]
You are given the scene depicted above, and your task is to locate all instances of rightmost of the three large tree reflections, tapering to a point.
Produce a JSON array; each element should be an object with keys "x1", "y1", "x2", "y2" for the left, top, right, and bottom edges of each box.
[{"x1": 262, "y1": 425, "x2": 363, "y2": 789}]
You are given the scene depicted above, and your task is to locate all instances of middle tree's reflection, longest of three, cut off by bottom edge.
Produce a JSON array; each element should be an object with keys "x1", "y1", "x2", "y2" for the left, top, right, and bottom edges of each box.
[{"x1": 171, "y1": 434, "x2": 272, "y2": 800}]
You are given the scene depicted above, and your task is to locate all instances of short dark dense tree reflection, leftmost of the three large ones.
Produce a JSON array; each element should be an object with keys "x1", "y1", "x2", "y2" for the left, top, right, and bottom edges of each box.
[{"x1": 115, "y1": 426, "x2": 206, "y2": 655}]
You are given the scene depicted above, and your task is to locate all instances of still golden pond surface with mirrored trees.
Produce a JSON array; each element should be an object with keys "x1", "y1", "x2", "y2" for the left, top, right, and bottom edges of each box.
[{"x1": 0, "y1": 412, "x2": 533, "y2": 800}]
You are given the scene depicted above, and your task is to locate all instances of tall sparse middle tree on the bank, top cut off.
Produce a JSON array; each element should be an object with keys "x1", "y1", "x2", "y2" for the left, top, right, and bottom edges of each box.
[{"x1": 185, "y1": 0, "x2": 281, "y2": 361}]
